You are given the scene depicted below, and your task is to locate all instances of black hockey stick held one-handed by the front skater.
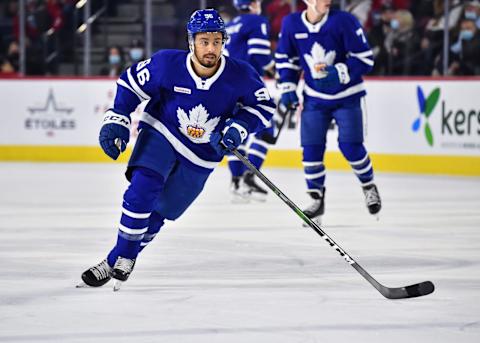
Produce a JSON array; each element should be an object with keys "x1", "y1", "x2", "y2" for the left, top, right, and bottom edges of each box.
[{"x1": 231, "y1": 149, "x2": 435, "y2": 299}]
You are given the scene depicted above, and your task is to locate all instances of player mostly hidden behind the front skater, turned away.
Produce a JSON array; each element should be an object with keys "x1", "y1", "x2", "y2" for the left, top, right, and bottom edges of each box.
[{"x1": 225, "y1": 0, "x2": 275, "y2": 202}]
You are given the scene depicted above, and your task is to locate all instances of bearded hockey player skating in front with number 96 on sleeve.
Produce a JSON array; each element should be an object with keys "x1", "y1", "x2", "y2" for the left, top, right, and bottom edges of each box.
[{"x1": 82, "y1": 9, "x2": 275, "y2": 290}]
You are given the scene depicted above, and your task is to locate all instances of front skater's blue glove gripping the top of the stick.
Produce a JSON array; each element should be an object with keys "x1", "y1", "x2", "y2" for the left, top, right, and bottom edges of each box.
[{"x1": 210, "y1": 119, "x2": 248, "y2": 155}]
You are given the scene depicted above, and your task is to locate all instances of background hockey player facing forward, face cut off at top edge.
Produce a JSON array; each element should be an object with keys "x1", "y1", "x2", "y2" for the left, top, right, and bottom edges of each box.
[{"x1": 275, "y1": 0, "x2": 381, "y2": 226}]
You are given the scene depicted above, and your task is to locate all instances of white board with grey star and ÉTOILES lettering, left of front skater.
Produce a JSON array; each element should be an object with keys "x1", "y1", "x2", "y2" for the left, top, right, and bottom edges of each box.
[{"x1": 0, "y1": 79, "x2": 116, "y2": 146}]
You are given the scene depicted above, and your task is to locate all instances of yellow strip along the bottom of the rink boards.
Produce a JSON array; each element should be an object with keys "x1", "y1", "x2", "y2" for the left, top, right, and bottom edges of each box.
[{"x1": 0, "y1": 145, "x2": 480, "y2": 176}]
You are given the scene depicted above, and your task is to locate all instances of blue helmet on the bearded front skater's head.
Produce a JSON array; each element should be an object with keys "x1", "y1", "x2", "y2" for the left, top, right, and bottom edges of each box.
[{"x1": 187, "y1": 8, "x2": 227, "y2": 41}]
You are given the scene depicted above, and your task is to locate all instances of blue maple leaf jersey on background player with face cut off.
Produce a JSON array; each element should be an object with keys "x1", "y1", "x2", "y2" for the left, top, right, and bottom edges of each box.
[{"x1": 275, "y1": 10, "x2": 374, "y2": 104}]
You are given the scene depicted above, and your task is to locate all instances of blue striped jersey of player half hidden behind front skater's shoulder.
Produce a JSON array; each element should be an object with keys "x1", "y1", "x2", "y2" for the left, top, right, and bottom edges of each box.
[{"x1": 225, "y1": 14, "x2": 274, "y2": 75}]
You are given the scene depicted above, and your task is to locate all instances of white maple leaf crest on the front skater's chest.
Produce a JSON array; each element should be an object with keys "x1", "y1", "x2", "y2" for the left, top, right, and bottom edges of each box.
[{"x1": 177, "y1": 104, "x2": 220, "y2": 144}]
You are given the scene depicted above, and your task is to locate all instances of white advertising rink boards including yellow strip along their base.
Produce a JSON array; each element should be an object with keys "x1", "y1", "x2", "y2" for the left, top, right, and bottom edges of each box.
[{"x1": 0, "y1": 78, "x2": 480, "y2": 176}]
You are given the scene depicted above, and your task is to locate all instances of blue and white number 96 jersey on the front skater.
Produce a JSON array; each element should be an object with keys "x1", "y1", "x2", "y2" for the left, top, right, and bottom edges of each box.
[{"x1": 114, "y1": 50, "x2": 275, "y2": 169}]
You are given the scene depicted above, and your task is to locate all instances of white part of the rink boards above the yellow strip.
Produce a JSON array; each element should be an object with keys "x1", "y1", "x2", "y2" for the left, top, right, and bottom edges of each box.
[{"x1": 0, "y1": 79, "x2": 480, "y2": 156}]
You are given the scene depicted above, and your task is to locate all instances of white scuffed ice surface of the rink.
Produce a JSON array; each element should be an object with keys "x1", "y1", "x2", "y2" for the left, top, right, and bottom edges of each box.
[{"x1": 0, "y1": 163, "x2": 480, "y2": 343}]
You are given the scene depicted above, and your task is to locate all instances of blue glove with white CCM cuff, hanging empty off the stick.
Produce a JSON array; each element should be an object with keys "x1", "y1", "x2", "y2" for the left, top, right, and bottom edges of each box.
[{"x1": 99, "y1": 110, "x2": 130, "y2": 160}]
